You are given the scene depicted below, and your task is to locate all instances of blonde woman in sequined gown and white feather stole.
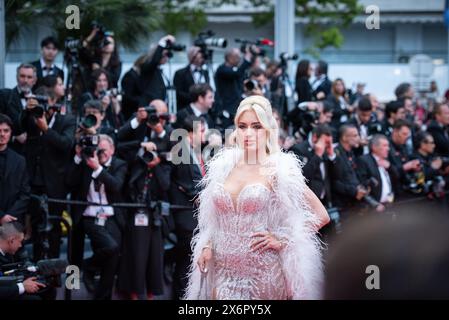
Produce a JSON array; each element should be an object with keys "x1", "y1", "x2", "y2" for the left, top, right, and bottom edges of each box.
[{"x1": 185, "y1": 96, "x2": 329, "y2": 300}]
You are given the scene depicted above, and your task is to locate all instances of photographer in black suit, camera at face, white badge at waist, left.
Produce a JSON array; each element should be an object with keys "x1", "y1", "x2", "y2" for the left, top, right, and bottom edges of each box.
[{"x1": 65, "y1": 135, "x2": 127, "y2": 300}]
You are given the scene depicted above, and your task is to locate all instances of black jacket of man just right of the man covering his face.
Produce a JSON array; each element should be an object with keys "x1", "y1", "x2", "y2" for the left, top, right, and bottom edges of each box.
[{"x1": 332, "y1": 145, "x2": 360, "y2": 207}]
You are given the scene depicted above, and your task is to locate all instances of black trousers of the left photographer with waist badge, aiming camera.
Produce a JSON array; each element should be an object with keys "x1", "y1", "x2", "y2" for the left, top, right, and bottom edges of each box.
[{"x1": 83, "y1": 217, "x2": 121, "y2": 300}]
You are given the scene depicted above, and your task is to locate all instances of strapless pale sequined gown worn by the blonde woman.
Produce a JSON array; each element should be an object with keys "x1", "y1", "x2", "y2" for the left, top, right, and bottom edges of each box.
[{"x1": 211, "y1": 183, "x2": 287, "y2": 300}]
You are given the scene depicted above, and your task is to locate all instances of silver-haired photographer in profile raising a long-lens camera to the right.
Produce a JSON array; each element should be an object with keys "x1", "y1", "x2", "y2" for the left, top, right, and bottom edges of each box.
[{"x1": 140, "y1": 35, "x2": 182, "y2": 105}]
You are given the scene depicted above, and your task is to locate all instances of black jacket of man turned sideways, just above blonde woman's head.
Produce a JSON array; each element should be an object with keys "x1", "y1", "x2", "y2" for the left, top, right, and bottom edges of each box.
[{"x1": 215, "y1": 60, "x2": 251, "y2": 116}]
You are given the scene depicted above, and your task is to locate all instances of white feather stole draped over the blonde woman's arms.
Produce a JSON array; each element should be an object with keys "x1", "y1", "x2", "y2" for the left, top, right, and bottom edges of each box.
[{"x1": 185, "y1": 147, "x2": 323, "y2": 300}]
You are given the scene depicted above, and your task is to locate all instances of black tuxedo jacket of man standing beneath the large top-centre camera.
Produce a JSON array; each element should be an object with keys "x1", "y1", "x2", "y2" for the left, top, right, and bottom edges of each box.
[{"x1": 173, "y1": 65, "x2": 209, "y2": 110}]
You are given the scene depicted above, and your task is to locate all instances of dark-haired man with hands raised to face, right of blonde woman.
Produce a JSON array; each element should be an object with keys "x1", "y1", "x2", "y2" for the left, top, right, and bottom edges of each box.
[{"x1": 291, "y1": 125, "x2": 335, "y2": 207}]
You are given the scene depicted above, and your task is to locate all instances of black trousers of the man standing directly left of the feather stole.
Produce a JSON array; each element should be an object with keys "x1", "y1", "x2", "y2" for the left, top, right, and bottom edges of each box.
[{"x1": 173, "y1": 228, "x2": 193, "y2": 300}]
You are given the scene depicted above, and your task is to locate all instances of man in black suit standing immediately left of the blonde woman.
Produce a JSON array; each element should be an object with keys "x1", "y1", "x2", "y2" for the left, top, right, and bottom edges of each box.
[{"x1": 169, "y1": 116, "x2": 205, "y2": 299}]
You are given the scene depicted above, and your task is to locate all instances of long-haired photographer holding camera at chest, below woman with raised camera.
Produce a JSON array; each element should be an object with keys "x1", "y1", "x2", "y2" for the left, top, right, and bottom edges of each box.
[{"x1": 78, "y1": 69, "x2": 124, "y2": 130}]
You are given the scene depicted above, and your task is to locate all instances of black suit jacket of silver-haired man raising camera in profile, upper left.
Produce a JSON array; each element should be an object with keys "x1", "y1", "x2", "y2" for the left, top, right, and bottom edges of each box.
[{"x1": 140, "y1": 46, "x2": 167, "y2": 105}]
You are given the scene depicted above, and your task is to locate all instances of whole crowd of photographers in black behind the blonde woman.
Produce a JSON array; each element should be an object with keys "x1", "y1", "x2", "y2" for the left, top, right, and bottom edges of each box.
[{"x1": 0, "y1": 24, "x2": 449, "y2": 299}]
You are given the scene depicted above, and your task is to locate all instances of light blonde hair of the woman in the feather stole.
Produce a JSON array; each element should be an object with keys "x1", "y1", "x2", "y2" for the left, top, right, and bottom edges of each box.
[{"x1": 233, "y1": 96, "x2": 280, "y2": 155}]
